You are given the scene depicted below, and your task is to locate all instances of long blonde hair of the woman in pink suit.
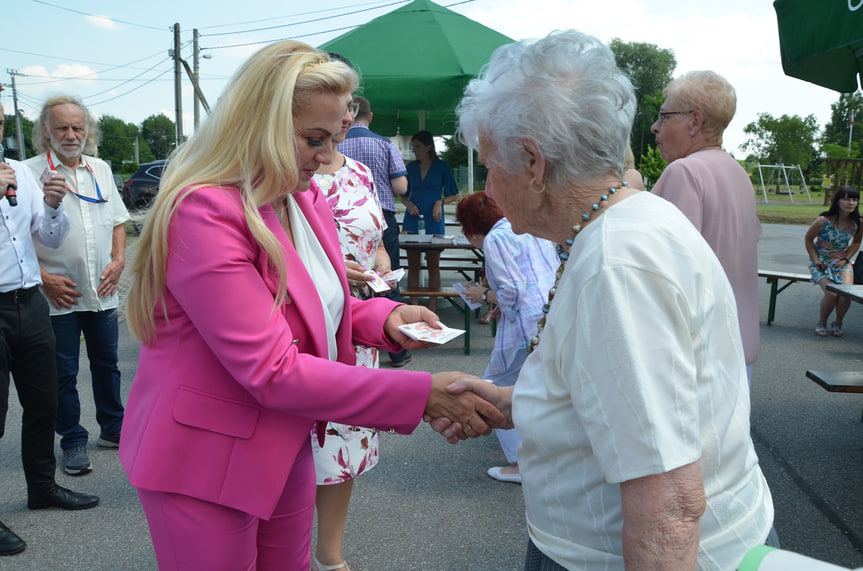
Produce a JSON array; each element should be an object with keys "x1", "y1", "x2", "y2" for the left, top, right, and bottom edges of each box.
[{"x1": 127, "y1": 41, "x2": 358, "y2": 343}]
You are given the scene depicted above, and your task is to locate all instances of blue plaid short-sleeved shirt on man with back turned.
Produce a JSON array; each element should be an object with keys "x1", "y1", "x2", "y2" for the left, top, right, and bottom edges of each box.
[{"x1": 339, "y1": 123, "x2": 408, "y2": 212}]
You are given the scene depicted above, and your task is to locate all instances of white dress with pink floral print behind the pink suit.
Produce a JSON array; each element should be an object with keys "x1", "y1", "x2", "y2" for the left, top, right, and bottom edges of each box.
[{"x1": 311, "y1": 157, "x2": 386, "y2": 485}]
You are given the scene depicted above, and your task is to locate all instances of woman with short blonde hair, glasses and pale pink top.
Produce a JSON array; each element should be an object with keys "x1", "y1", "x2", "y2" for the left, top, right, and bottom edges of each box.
[{"x1": 651, "y1": 71, "x2": 761, "y2": 379}]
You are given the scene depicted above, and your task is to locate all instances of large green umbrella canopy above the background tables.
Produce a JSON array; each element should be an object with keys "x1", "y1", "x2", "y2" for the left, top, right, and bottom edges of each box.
[{"x1": 319, "y1": 0, "x2": 513, "y2": 136}]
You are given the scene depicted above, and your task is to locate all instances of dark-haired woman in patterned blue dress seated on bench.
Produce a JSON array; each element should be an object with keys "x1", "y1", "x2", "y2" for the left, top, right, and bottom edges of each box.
[{"x1": 806, "y1": 186, "x2": 863, "y2": 337}]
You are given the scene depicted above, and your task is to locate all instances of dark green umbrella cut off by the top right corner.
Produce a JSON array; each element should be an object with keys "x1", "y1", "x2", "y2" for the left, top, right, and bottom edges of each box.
[{"x1": 773, "y1": 0, "x2": 863, "y2": 92}]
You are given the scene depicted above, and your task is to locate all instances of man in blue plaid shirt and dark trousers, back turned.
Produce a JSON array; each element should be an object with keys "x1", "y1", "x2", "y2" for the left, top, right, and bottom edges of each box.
[{"x1": 339, "y1": 96, "x2": 411, "y2": 367}]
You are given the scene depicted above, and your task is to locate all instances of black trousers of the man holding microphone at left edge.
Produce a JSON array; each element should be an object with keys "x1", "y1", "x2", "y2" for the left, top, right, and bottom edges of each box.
[{"x1": 0, "y1": 286, "x2": 57, "y2": 494}]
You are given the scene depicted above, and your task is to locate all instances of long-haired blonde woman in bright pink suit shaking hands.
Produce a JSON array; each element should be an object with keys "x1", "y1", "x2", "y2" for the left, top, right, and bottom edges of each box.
[{"x1": 120, "y1": 41, "x2": 502, "y2": 571}]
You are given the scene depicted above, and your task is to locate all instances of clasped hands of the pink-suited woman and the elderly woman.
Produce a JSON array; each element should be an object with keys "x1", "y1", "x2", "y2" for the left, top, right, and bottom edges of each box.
[{"x1": 423, "y1": 372, "x2": 508, "y2": 444}]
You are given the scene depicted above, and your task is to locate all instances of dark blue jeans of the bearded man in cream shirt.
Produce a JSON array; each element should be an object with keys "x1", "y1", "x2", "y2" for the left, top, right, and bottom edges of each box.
[{"x1": 51, "y1": 308, "x2": 125, "y2": 450}]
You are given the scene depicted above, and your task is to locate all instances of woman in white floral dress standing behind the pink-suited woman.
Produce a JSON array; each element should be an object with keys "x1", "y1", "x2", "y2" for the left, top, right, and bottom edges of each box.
[{"x1": 311, "y1": 106, "x2": 390, "y2": 571}]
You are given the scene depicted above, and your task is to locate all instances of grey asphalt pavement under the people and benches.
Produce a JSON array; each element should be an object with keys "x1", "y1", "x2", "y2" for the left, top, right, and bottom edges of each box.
[{"x1": 0, "y1": 225, "x2": 863, "y2": 571}]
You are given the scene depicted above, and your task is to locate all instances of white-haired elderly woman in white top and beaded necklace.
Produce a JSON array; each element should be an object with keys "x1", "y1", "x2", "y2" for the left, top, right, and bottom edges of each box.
[{"x1": 433, "y1": 31, "x2": 773, "y2": 570}]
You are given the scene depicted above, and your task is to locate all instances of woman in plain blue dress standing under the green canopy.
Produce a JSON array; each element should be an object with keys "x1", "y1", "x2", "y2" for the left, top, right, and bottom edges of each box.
[{"x1": 402, "y1": 131, "x2": 458, "y2": 311}]
